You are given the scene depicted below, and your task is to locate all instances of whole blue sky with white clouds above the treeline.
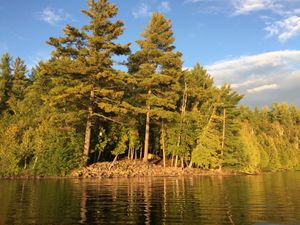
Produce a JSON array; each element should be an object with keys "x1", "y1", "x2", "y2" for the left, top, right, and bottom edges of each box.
[{"x1": 0, "y1": 0, "x2": 300, "y2": 107}]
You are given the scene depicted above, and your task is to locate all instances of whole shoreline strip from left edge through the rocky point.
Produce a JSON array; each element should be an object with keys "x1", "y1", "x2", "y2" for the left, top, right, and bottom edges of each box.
[{"x1": 0, "y1": 160, "x2": 262, "y2": 180}]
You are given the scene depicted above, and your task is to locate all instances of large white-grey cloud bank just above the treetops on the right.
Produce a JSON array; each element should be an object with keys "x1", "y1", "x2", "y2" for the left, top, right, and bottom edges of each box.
[{"x1": 206, "y1": 50, "x2": 300, "y2": 106}]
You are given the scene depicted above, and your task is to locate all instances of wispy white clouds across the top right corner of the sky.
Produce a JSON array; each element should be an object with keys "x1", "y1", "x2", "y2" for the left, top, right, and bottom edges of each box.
[{"x1": 185, "y1": 0, "x2": 300, "y2": 43}]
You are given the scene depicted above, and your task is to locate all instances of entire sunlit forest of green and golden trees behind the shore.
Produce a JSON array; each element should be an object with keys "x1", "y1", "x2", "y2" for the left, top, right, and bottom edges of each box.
[{"x1": 0, "y1": 0, "x2": 300, "y2": 176}]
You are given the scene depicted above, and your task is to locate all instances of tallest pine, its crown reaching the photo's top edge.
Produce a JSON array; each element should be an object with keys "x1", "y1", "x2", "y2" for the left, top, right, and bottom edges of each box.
[{"x1": 44, "y1": 0, "x2": 129, "y2": 163}]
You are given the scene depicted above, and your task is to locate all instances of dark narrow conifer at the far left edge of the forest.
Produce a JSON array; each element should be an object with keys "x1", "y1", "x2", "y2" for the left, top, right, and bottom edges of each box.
[{"x1": 0, "y1": 53, "x2": 12, "y2": 113}]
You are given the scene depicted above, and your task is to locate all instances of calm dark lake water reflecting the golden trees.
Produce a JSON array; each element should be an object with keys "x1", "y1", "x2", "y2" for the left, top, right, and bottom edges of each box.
[{"x1": 0, "y1": 172, "x2": 300, "y2": 225}]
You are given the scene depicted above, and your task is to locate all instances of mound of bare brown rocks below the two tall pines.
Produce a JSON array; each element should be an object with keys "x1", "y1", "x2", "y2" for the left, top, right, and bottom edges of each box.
[{"x1": 70, "y1": 160, "x2": 245, "y2": 178}]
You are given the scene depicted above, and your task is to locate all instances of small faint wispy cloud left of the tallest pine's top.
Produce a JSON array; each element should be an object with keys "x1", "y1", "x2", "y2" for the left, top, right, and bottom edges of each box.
[{"x1": 39, "y1": 7, "x2": 70, "y2": 25}]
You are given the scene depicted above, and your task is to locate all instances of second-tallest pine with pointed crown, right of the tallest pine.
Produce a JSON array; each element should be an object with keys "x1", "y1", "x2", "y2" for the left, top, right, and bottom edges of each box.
[{"x1": 128, "y1": 13, "x2": 182, "y2": 161}]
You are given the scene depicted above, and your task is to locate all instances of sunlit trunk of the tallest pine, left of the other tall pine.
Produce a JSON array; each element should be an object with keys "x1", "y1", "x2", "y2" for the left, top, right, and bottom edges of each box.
[{"x1": 83, "y1": 90, "x2": 95, "y2": 164}]
